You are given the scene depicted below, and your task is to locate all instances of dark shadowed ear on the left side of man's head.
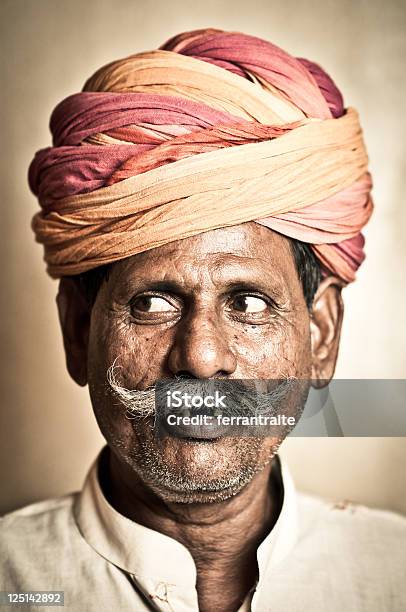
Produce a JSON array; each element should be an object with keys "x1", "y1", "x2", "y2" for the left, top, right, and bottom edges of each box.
[{"x1": 56, "y1": 277, "x2": 91, "y2": 387}]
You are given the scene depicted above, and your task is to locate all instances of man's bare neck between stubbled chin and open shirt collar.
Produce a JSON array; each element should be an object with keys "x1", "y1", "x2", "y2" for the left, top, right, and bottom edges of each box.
[{"x1": 102, "y1": 444, "x2": 281, "y2": 612}]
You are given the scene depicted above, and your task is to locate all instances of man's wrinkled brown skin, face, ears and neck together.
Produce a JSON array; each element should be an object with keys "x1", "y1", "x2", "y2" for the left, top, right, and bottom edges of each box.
[{"x1": 58, "y1": 223, "x2": 342, "y2": 611}]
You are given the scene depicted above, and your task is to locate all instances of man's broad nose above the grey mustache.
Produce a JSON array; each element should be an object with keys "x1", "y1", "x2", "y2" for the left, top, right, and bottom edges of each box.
[{"x1": 168, "y1": 309, "x2": 237, "y2": 378}]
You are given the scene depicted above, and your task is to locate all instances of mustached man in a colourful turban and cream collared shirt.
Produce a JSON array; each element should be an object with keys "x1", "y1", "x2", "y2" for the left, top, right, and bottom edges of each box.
[{"x1": 1, "y1": 30, "x2": 406, "y2": 612}]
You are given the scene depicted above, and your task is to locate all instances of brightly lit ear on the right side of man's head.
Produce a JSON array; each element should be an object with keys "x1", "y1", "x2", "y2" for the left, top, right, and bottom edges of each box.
[{"x1": 310, "y1": 276, "x2": 345, "y2": 388}]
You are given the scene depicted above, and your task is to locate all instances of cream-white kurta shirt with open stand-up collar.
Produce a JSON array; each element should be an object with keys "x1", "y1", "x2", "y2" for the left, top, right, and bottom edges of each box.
[{"x1": 0, "y1": 444, "x2": 406, "y2": 612}]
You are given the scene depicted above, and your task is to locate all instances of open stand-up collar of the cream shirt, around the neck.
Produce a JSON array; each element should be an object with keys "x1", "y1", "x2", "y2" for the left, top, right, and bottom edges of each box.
[{"x1": 74, "y1": 446, "x2": 297, "y2": 588}]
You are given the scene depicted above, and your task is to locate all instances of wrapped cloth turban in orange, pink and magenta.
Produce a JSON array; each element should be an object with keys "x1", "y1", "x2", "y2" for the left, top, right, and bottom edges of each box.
[{"x1": 29, "y1": 29, "x2": 373, "y2": 283}]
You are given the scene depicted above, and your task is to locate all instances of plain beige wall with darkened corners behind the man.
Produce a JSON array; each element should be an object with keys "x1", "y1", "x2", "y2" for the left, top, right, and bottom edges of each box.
[{"x1": 0, "y1": 0, "x2": 406, "y2": 512}]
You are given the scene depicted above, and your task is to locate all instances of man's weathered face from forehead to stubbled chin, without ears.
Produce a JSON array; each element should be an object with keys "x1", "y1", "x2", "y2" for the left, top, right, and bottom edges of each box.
[{"x1": 82, "y1": 223, "x2": 311, "y2": 502}]
